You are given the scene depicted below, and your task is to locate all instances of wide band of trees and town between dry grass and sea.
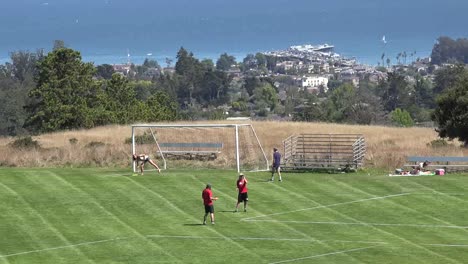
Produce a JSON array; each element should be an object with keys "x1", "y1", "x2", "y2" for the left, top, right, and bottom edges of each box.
[{"x1": 0, "y1": 43, "x2": 468, "y2": 145}]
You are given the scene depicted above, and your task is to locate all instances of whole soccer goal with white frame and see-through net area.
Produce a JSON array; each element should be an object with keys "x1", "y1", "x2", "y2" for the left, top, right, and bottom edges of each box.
[{"x1": 131, "y1": 124, "x2": 269, "y2": 172}]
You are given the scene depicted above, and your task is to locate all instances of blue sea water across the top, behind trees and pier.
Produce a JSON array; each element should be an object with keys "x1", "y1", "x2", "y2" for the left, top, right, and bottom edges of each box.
[{"x1": 0, "y1": 0, "x2": 468, "y2": 65}]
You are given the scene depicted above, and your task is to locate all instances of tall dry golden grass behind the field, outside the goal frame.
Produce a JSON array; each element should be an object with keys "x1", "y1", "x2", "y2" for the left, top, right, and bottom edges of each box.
[{"x1": 0, "y1": 121, "x2": 468, "y2": 169}]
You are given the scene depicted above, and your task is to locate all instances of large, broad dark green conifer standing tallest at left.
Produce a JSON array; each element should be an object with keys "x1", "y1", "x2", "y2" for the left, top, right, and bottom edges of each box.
[{"x1": 25, "y1": 48, "x2": 96, "y2": 132}]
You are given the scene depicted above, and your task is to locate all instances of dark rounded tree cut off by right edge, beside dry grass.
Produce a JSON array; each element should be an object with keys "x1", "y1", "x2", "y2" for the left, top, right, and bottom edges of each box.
[{"x1": 432, "y1": 72, "x2": 468, "y2": 146}]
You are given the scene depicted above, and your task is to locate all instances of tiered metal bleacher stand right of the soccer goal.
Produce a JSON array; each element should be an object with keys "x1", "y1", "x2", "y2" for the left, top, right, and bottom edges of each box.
[{"x1": 282, "y1": 134, "x2": 366, "y2": 171}]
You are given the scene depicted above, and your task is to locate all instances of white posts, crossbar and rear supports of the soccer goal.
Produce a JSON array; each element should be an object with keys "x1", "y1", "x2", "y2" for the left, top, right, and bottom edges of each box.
[{"x1": 131, "y1": 124, "x2": 270, "y2": 173}]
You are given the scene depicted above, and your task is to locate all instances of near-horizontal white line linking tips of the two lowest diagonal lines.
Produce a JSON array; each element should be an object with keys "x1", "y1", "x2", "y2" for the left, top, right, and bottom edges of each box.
[{"x1": 146, "y1": 235, "x2": 388, "y2": 244}]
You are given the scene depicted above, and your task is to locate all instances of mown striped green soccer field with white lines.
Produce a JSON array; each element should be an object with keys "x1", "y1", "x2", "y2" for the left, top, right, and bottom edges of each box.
[{"x1": 0, "y1": 168, "x2": 468, "y2": 264}]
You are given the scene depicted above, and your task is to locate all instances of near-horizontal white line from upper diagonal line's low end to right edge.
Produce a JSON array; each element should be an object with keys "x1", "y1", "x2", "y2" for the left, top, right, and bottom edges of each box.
[{"x1": 245, "y1": 219, "x2": 468, "y2": 229}]
